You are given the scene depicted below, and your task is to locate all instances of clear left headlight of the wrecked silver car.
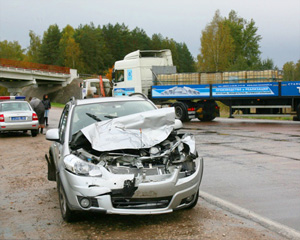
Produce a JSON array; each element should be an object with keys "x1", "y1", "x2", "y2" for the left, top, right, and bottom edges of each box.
[{"x1": 64, "y1": 154, "x2": 102, "y2": 177}]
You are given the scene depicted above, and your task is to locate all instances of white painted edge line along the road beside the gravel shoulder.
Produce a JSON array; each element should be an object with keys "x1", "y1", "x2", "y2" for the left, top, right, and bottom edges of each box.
[{"x1": 199, "y1": 191, "x2": 300, "y2": 239}]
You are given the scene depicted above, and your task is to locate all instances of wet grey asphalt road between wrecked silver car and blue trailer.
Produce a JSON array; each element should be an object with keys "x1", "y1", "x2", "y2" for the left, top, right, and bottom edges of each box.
[{"x1": 184, "y1": 118, "x2": 300, "y2": 231}]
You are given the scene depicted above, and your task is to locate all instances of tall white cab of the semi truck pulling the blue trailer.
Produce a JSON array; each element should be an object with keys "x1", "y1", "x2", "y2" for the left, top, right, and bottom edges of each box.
[{"x1": 113, "y1": 49, "x2": 176, "y2": 96}]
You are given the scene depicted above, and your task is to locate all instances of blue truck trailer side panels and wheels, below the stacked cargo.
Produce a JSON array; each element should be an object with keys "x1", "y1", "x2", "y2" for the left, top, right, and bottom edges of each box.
[{"x1": 151, "y1": 81, "x2": 300, "y2": 121}]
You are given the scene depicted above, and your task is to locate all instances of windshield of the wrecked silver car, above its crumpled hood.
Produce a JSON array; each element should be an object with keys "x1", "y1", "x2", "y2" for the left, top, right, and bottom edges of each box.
[{"x1": 71, "y1": 100, "x2": 155, "y2": 135}]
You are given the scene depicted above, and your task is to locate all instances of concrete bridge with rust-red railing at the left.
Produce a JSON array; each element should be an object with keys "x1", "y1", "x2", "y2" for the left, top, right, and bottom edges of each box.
[{"x1": 0, "y1": 58, "x2": 78, "y2": 95}]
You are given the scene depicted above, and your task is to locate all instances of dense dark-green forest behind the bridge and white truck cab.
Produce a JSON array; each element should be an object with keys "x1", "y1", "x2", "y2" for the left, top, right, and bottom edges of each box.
[{"x1": 0, "y1": 23, "x2": 196, "y2": 74}]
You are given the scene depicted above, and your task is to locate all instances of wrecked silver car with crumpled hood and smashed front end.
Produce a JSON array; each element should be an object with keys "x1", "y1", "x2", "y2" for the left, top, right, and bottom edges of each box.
[{"x1": 46, "y1": 96, "x2": 203, "y2": 221}]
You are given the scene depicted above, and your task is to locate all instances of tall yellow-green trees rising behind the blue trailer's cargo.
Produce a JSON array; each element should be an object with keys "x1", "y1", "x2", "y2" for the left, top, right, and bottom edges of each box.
[{"x1": 197, "y1": 10, "x2": 300, "y2": 80}]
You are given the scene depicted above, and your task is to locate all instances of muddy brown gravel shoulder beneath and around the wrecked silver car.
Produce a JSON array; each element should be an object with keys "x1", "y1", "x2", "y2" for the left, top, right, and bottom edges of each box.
[{"x1": 0, "y1": 109, "x2": 283, "y2": 239}]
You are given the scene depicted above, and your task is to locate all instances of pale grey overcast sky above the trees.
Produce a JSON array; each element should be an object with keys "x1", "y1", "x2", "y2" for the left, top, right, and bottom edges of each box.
[{"x1": 0, "y1": 0, "x2": 300, "y2": 68}]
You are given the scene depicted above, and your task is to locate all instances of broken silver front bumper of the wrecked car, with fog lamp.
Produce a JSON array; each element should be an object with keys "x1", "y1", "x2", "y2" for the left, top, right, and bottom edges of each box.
[{"x1": 59, "y1": 158, "x2": 203, "y2": 215}]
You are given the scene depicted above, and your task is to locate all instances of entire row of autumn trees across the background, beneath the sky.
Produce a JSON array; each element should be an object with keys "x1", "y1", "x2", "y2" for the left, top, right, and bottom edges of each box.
[{"x1": 0, "y1": 10, "x2": 300, "y2": 80}]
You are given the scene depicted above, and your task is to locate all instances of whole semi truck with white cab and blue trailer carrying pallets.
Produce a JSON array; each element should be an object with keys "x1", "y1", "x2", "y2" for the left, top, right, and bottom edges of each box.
[{"x1": 113, "y1": 49, "x2": 300, "y2": 122}]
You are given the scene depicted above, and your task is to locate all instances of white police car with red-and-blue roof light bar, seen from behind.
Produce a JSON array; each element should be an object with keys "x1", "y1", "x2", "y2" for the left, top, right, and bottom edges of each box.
[{"x1": 0, "y1": 96, "x2": 39, "y2": 137}]
